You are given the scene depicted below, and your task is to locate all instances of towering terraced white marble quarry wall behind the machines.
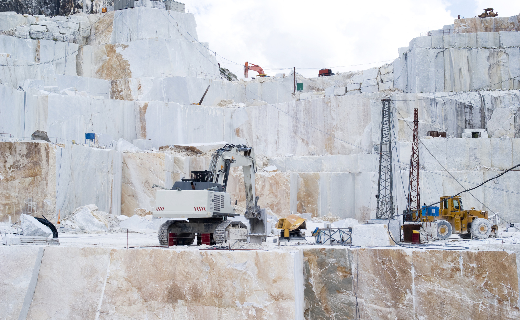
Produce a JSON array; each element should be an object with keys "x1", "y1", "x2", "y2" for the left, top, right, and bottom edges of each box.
[{"x1": 0, "y1": 6, "x2": 520, "y2": 221}]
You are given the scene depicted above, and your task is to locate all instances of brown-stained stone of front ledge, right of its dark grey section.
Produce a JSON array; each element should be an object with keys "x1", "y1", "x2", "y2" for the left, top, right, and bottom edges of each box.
[{"x1": 352, "y1": 249, "x2": 518, "y2": 319}]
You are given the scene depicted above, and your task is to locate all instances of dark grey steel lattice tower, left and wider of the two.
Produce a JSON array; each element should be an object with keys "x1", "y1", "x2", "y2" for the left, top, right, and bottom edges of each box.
[{"x1": 376, "y1": 99, "x2": 394, "y2": 219}]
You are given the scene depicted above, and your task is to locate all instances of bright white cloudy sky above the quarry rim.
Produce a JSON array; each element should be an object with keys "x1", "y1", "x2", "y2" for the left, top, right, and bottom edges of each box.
[{"x1": 180, "y1": 0, "x2": 520, "y2": 78}]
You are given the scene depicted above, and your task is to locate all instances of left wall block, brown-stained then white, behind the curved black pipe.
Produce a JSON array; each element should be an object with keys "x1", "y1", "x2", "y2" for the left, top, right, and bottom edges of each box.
[{"x1": 0, "y1": 141, "x2": 122, "y2": 222}]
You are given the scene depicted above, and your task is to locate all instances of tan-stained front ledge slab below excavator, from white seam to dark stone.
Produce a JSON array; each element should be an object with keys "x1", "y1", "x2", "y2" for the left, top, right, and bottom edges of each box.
[{"x1": 99, "y1": 249, "x2": 303, "y2": 319}]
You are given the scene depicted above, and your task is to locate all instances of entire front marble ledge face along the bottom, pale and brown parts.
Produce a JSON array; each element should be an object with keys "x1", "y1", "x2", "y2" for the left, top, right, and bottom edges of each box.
[{"x1": 0, "y1": 247, "x2": 520, "y2": 319}]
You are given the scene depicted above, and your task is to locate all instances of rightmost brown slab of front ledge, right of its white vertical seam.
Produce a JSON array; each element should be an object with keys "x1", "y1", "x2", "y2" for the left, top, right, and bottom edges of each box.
[{"x1": 411, "y1": 251, "x2": 519, "y2": 319}]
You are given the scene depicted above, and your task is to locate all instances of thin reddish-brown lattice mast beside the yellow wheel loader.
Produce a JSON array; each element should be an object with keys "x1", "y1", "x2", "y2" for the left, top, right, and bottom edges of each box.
[{"x1": 408, "y1": 108, "x2": 421, "y2": 220}]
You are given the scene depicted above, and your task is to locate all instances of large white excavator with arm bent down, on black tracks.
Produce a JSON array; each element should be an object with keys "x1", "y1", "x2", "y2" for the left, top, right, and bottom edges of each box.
[{"x1": 153, "y1": 144, "x2": 266, "y2": 246}]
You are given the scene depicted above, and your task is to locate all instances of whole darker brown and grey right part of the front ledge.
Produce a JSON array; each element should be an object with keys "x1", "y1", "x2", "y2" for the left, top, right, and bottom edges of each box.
[{"x1": 304, "y1": 249, "x2": 519, "y2": 319}]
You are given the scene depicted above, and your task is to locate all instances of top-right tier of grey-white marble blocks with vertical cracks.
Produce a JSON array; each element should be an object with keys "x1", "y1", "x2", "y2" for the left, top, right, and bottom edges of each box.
[{"x1": 394, "y1": 31, "x2": 520, "y2": 93}]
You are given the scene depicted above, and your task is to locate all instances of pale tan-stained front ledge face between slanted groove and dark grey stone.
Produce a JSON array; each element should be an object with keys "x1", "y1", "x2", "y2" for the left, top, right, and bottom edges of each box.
[{"x1": 18, "y1": 247, "x2": 302, "y2": 319}]
